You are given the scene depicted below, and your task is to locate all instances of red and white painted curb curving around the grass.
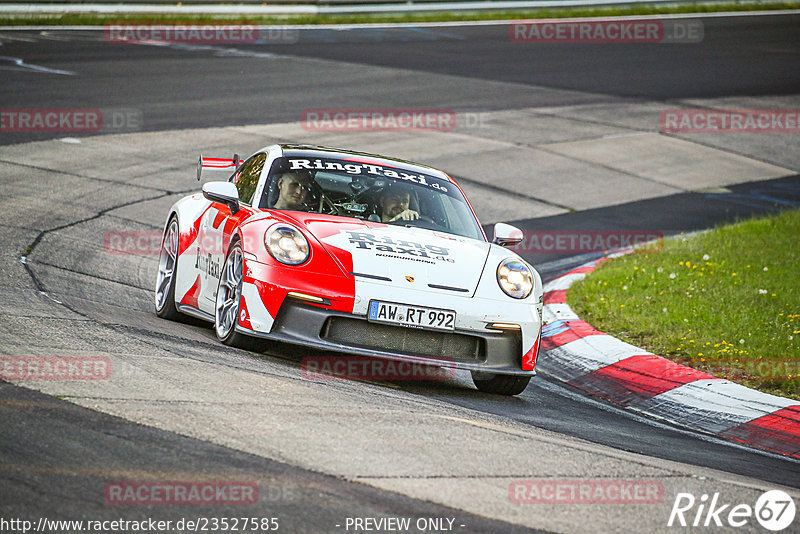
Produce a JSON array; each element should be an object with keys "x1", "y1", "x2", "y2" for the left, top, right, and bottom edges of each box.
[{"x1": 537, "y1": 252, "x2": 800, "y2": 458}]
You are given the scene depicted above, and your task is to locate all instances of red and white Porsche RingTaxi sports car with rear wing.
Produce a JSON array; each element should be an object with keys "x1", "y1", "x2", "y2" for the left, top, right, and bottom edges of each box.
[{"x1": 155, "y1": 145, "x2": 542, "y2": 395}]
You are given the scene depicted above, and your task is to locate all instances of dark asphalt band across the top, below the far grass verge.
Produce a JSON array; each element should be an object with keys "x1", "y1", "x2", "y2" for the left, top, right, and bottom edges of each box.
[{"x1": 0, "y1": 15, "x2": 800, "y2": 144}]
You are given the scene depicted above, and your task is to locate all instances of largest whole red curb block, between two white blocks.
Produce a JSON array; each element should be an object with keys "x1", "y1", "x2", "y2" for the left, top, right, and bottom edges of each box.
[{"x1": 569, "y1": 354, "x2": 714, "y2": 406}]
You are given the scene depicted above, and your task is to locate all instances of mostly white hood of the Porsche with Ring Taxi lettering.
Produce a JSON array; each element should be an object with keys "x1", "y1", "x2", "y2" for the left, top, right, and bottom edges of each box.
[{"x1": 298, "y1": 216, "x2": 490, "y2": 296}]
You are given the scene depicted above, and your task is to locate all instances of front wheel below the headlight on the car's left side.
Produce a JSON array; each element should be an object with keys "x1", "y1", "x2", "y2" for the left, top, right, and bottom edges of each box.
[{"x1": 214, "y1": 241, "x2": 264, "y2": 351}]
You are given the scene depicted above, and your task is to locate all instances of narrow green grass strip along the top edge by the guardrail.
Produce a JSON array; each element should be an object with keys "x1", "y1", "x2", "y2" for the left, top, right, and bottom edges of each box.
[{"x1": 0, "y1": 2, "x2": 800, "y2": 26}]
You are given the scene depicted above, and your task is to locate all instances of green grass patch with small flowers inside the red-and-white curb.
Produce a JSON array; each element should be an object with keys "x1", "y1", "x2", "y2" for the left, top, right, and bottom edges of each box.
[{"x1": 568, "y1": 211, "x2": 800, "y2": 399}]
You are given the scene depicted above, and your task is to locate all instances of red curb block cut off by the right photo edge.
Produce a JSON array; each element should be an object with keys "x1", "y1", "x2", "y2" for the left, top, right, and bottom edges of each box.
[{"x1": 720, "y1": 405, "x2": 800, "y2": 458}]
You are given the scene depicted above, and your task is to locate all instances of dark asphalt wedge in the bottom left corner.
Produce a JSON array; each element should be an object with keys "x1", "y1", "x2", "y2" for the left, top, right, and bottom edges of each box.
[{"x1": 0, "y1": 381, "x2": 535, "y2": 533}]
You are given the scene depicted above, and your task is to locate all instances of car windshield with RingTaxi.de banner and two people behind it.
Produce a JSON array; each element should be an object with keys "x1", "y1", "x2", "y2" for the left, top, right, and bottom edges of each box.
[{"x1": 259, "y1": 156, "x2": 484, "y2": 240}]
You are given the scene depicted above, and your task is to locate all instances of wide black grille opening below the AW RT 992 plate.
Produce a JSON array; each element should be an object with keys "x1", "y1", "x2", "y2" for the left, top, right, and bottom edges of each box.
[{"x1": 320, "y1": 317, "x2": 486, "y2": 363}]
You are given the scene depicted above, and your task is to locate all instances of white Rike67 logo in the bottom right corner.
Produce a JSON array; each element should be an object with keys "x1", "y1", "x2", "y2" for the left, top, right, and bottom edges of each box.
[{"x1": 667, "y1": 490, "x2": 797, "y2": 532}]
